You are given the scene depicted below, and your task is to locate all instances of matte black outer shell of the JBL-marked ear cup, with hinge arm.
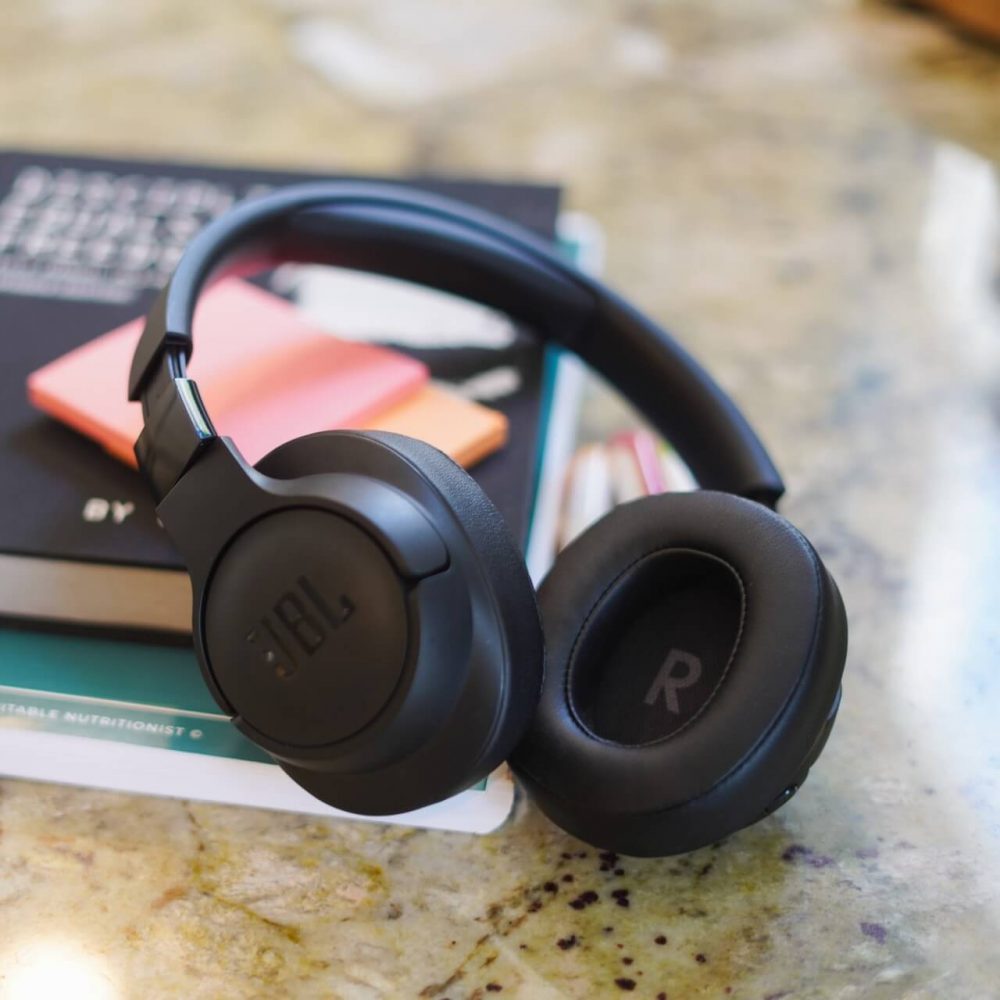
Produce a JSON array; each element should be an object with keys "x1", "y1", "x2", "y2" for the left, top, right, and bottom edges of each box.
[{"x1": 158, "y1": 439, "x2": 471, "y2": 784}]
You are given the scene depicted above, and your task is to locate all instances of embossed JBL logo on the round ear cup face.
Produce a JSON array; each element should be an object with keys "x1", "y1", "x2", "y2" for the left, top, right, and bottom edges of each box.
[{"x1": 246, "y1": 576, "x2": 354, "y2": 677}]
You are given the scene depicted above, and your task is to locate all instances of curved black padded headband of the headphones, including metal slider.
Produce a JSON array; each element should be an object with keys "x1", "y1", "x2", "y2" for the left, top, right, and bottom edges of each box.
[{"x1": 129, "y1": 182, "x2": 784, "y2": 506}]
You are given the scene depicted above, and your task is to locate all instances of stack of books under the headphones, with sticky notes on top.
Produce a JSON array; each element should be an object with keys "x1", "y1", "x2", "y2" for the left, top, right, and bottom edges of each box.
[{"x1": 0, "y1": 152, "x2": 596, "y2": 831}]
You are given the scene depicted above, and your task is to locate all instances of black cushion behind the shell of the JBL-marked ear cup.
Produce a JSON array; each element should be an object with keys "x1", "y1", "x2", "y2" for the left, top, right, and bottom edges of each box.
[{"x1": 257, "y1": 431, "x2": 543, "y2": 815}]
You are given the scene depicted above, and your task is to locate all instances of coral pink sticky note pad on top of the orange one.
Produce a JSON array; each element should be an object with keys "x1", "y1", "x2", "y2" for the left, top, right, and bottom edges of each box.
[{"x1": 28, "y1": 279, "x2": 428, "y2": 465}]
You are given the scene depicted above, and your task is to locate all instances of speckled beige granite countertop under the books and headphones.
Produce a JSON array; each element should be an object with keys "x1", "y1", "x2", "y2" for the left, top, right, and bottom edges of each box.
[{"x1": 0, "y1": 0, "x2": 1000, "y2": 1000}]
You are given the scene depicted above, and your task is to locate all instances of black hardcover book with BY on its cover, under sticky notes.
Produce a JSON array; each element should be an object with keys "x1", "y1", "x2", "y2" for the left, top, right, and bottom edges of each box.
[{"x1": 0, "y1": 152, "x2": 559, "y2": 634}]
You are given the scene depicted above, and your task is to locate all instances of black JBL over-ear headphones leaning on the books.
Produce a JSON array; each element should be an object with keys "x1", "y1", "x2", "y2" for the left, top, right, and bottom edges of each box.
[{"x1": 129, "y1": 182, "x2": 847, "y2": 855}]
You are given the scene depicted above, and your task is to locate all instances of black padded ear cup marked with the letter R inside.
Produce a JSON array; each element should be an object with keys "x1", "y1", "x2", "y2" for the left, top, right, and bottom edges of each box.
[{"x1": 511, "y1": 492, "x2": 847, "y2": 856}]
